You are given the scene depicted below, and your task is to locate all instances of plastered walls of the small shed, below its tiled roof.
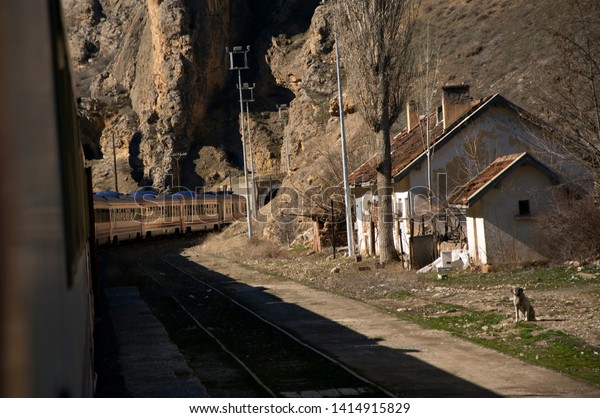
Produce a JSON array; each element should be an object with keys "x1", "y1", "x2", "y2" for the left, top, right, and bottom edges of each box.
[{"x1": 467, "y1": 164, "x2": 561, "y2": 264}]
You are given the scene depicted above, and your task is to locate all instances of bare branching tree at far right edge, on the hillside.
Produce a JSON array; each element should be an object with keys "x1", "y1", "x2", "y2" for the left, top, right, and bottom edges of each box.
[{"x1": 545, "y1": 0, "x2": 600, "y2": 195}]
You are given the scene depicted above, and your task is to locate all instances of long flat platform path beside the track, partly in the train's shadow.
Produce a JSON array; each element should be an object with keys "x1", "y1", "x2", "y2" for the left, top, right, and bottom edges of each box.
[{"x1": 187, "y1": 251, "x2": 600, "y2": 397}]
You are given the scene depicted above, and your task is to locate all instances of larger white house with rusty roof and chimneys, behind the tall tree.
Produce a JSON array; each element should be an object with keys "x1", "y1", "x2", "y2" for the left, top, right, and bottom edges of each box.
[{"x1": 349, "y1": 85, "x2": 580, "y2": 267}]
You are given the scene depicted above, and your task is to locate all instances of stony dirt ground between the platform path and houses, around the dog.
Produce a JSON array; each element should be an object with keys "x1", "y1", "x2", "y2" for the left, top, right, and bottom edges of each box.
[{"x1": 189, "y1": 228, "x2": 600, "y2": 352}]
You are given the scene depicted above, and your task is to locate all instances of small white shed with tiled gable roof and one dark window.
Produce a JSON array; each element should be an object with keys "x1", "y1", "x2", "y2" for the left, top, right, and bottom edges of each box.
[{"x1": 449, "y1": 152, "x2": 568, "y2": 265}]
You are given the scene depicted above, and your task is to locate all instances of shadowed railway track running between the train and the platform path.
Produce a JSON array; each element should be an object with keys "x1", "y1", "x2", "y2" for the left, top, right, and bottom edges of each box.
[{"x1": 131, "y1": 251, "x2": 393, "y2": 397}]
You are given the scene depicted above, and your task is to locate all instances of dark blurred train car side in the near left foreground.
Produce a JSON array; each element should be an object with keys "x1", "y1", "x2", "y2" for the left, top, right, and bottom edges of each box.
[{"x1": 0, "y1": 0, "x2": 94, "y2": 397}]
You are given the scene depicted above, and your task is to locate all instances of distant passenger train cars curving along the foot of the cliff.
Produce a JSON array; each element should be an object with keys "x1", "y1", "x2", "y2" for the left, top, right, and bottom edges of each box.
[{"x1": 94, "y1": 190, "x2": 246, "y2": 245}]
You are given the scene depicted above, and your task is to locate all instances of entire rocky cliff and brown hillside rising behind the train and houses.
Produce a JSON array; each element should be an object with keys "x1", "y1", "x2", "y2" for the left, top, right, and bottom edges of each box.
[{"x1": 63, "y1": 0, "x2": 568, "y2": 191}]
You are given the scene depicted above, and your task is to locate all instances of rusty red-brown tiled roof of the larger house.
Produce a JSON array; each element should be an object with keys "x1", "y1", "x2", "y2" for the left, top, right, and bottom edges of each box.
[{"x1": 348, "y1": 95, "x2": 492, "y2": 185}]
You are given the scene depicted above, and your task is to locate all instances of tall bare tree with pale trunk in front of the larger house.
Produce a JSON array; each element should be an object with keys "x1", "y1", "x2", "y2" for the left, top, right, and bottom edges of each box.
[{"x1": 335, "y1": 0, "x2": 419, "y2": 263}]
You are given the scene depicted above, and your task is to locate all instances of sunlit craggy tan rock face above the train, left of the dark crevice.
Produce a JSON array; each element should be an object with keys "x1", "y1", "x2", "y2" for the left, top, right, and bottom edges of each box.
[{"x1": 63, "y1": 0, "x2": 231, "y2": 191}]
